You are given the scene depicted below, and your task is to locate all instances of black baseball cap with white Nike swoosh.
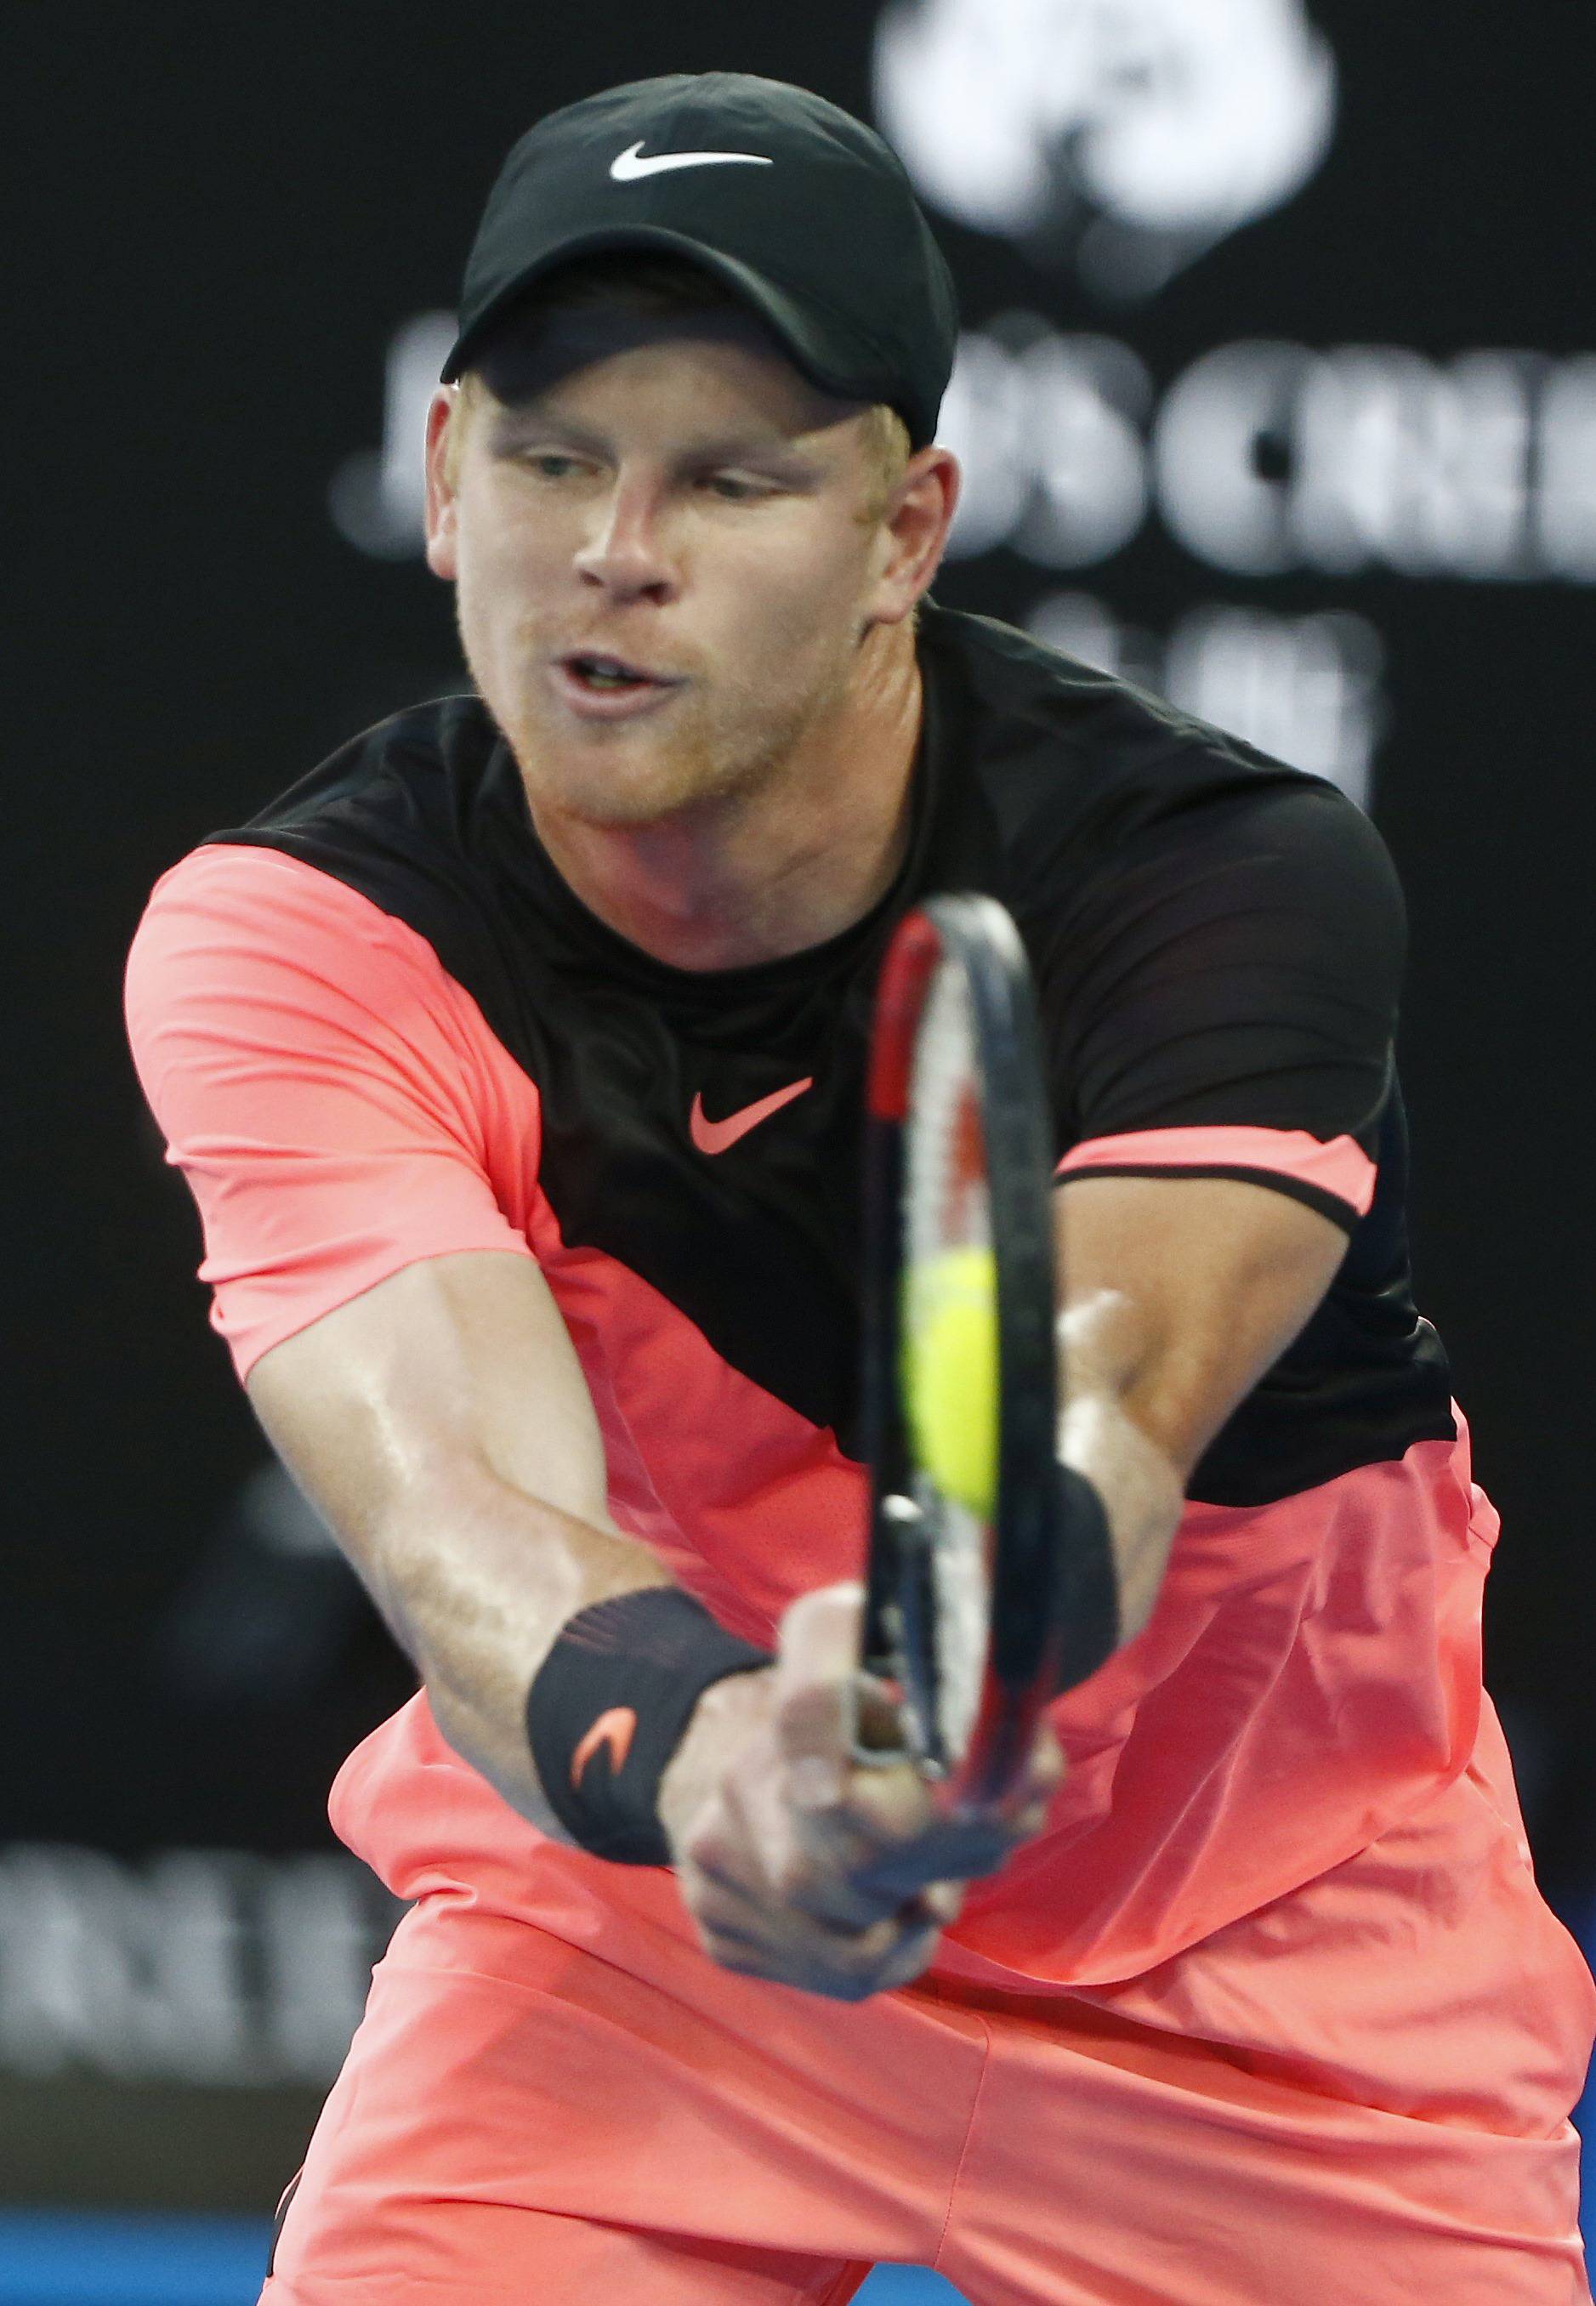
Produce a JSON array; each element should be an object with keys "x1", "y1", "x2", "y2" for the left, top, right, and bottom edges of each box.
[{"x1": 443, "y1": 71, "x2": 959, "y2": 447}]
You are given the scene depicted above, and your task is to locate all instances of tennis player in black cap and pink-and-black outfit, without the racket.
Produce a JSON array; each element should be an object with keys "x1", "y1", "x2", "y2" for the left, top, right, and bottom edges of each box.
[{"x1": 129, "y1": 74, "x2": 1596, "y2": 2306}]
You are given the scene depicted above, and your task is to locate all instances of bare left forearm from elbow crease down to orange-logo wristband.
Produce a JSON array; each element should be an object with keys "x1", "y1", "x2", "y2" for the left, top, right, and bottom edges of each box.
[{"x1": 362, "y1": 1467, "x2": 671, "y2": 1840}]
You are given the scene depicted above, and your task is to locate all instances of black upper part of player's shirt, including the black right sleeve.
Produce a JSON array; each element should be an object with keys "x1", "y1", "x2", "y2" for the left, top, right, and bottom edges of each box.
[{"x1": 213, "y1": 602, "x2": 1456, "y2": 1506}]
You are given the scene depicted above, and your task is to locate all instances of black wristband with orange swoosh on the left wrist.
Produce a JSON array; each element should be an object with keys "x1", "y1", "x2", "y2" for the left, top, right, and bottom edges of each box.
[{"x1": 525, "y1": 1587, "x2": 773, "y2": 1866}]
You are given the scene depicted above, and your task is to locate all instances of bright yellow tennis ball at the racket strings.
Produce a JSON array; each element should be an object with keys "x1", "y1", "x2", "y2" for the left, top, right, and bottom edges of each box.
[{"x1": 902, "y1": 1247, "x2": 998, "y2": 1517}]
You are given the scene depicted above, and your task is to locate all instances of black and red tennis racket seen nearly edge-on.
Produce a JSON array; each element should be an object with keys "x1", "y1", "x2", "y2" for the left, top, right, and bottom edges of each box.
[{"x1": 855, "y1": 897, "x2": 1063, "y2": 1813}]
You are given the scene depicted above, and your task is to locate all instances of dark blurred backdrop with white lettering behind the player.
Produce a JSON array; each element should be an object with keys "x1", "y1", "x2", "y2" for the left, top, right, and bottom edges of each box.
[{"x1": 0, "y1": 0, "x2": 1596, "y2": 2269}]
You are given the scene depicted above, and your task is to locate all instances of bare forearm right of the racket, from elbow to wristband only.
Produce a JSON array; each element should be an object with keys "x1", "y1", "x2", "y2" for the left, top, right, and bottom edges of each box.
[{"x1": 1059, "y1": 1292, "x2": 1183, "y2": 1644}]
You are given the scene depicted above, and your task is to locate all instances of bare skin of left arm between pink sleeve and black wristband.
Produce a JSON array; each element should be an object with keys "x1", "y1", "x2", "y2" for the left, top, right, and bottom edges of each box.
[{"x1": 247, "y1": 1252, "x2": 669, "y2": 1837}]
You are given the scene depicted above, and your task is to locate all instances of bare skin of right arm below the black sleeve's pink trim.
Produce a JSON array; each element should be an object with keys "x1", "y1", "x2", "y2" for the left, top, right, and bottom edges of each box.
[{"x1": 1054, "y1": 1173, "x2": 1347, "y2": 1642}]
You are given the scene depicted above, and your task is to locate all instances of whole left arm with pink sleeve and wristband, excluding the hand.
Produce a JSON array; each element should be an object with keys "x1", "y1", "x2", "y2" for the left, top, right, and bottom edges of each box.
[{"x1": 127, "y1": 846, "x2": 766, "y2": 1856}]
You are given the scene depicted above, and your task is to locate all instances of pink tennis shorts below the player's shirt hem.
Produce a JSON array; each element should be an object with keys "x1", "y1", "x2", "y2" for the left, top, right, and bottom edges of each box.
[{"x1": 263, "y1": 1715, "x2": 1596, "y2": 2306}]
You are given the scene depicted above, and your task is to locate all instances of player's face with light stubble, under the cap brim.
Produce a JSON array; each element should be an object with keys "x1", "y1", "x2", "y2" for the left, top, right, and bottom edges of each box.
[{"x1": 429, "y1": 311, "x2": 906, "y2": 826}]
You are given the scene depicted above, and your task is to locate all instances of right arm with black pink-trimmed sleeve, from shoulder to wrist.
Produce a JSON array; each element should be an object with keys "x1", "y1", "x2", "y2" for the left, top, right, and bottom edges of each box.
[{"x1": 1042, "y1": 752, "x2": 1405, "y2": 1669}]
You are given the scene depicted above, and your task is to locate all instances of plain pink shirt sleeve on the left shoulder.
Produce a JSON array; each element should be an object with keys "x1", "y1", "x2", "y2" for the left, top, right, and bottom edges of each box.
[{"x1": 127, "y1": 846, "x2": 537, "y2": 1379}]
